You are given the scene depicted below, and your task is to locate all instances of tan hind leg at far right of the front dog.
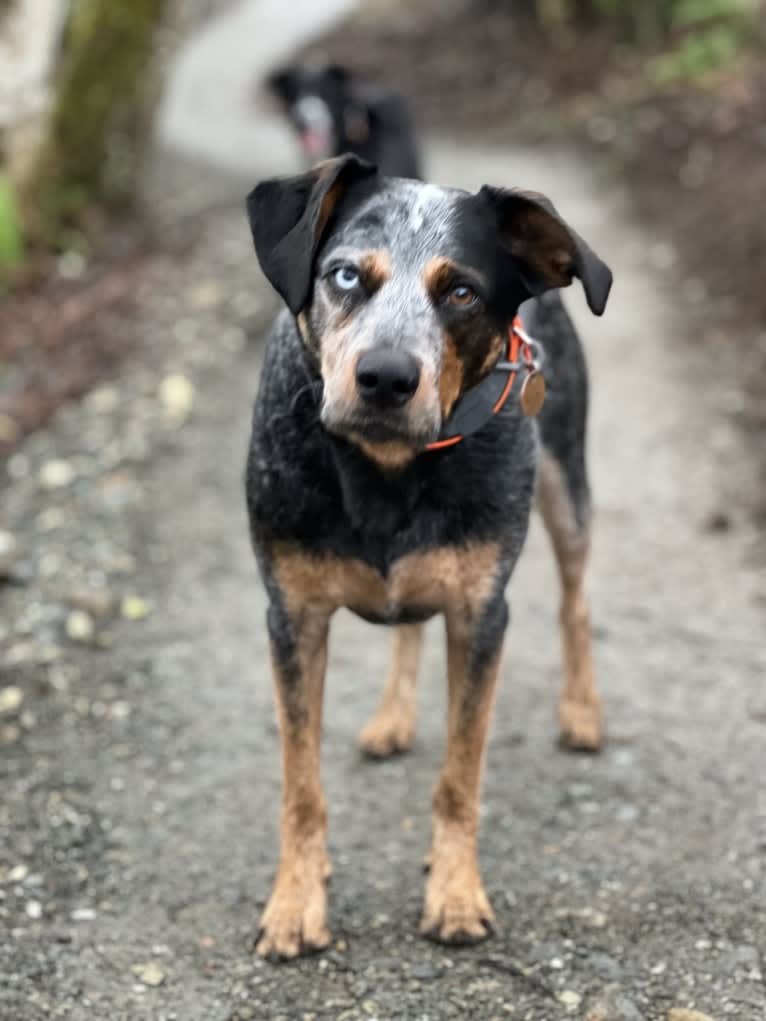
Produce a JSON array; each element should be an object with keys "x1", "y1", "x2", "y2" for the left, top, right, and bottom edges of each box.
[{"x1": 537, "y1": 455, "x2": 604, "y2": 751}]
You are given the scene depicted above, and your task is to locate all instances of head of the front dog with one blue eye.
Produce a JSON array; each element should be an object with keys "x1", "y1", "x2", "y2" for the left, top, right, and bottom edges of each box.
[{"x1": 247, "y1": 156, "x2": 612, "y2": 465}]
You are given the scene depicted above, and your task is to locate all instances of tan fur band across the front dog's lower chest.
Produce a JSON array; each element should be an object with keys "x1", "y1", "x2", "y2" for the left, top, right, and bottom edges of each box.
[{"x1": 275, "y1": 543, "x2": 499, "y2": 624}]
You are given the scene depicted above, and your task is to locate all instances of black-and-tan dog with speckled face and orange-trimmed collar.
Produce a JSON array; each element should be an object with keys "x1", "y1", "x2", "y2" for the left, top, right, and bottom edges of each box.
[{"x1": 246, "y1": 155, "x2": 612, "y2": 959}]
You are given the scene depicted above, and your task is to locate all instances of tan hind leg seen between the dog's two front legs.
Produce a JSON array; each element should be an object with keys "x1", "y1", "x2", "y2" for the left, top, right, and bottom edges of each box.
[{"x1": 360, "y1": 624, "x2": 423, "y2": 759}]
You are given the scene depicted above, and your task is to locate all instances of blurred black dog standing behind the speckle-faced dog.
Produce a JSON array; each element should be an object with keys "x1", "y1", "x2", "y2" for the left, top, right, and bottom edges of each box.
[{"x1": 267, "y1": 64, "x2": 421, "y2": 178}]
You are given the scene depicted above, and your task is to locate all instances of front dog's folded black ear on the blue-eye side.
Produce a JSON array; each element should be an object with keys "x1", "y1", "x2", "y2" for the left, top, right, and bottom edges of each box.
[{"x1": 247, "y1": 154, "x2": 377, "y2": 315}]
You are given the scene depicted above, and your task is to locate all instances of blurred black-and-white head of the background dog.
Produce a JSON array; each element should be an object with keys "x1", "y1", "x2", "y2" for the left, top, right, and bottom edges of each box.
[{"x1": 267, "y1": 64, "x2": 369, "y2": 162}]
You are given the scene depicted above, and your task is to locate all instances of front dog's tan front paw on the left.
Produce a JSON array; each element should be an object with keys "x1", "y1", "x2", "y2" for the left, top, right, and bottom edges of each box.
[{"x1": 255, "y1": 864, "x2": 330, "y2": 961}]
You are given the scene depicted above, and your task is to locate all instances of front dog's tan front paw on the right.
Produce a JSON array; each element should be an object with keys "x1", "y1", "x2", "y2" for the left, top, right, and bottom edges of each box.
[{"x1": 420, "y1": 864, "x2": 495, "y2": 944}]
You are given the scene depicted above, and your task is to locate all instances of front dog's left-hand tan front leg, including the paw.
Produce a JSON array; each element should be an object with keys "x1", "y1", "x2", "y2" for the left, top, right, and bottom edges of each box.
[{"x1": 255, "y1": 599, "x2": 330, "y2": 958}]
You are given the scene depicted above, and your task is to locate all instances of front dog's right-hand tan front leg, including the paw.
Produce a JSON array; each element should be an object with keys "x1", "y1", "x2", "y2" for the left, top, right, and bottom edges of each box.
[{"x1": 420, "y1": 595, "x2": 508, "y2": 942}]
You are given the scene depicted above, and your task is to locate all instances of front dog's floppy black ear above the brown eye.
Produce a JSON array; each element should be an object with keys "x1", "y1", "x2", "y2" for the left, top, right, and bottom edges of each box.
[{"x1": 479, "y1": 185, "x2": 612, "y2": 315}]
